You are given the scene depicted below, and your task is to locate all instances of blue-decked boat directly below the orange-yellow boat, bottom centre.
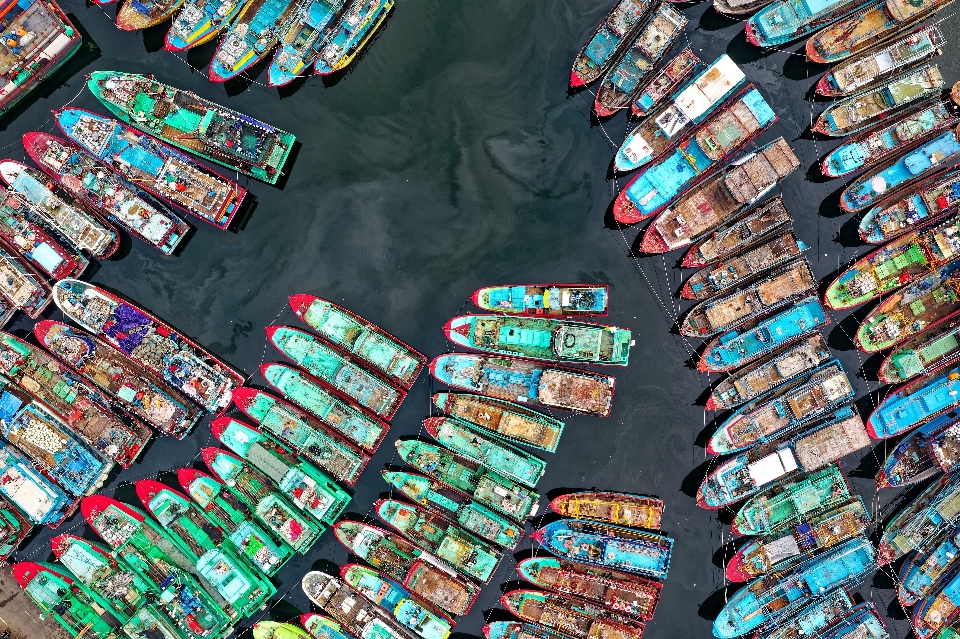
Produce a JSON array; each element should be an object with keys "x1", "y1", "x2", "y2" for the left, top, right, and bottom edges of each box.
[{"x1": 530, "y1": 519, "x2": 673, "y2": 579}]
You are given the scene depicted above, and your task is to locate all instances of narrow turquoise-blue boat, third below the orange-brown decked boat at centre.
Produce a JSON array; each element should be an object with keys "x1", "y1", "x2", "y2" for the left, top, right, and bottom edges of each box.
[{"x1": 381, "y1": 470, "x2": 523, "y2": 550}]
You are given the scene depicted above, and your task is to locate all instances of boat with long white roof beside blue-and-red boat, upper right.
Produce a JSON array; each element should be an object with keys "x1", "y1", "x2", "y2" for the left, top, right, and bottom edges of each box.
[{"x1": 613, "y1": 54, "x2": 753, "y2": 173}]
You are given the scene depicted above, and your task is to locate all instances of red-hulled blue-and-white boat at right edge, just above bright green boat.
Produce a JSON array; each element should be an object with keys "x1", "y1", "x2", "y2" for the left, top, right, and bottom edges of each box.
[{"x1": 860, "y1": 170, "x2": 960, "y2": 244}]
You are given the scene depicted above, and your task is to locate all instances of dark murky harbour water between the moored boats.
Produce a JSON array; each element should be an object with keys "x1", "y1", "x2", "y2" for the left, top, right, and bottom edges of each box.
[{"x1": 0, "y1": 0, "x2": 958, "y2": 639}]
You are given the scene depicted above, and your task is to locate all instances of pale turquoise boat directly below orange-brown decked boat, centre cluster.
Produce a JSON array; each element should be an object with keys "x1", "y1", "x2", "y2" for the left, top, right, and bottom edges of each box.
[{"x1": 423, "y1": 417, "x2": 547, "y2": 488}]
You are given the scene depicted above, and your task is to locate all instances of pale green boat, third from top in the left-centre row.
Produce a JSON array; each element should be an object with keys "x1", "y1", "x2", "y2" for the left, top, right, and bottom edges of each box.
[{"x1": 260, "y1": 363, "x2": 390, "y2": 453}]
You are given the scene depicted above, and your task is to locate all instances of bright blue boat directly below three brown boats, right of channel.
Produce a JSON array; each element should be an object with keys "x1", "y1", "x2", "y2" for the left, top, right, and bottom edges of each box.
[{"x1": 697, "y1": 297, "x2": 830, "y2": 372}]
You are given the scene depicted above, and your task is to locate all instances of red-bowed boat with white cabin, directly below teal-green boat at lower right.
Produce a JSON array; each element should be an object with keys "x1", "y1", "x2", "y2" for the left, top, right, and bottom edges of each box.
[{"x1": 725, "y1": 497, "x2": 870, "y2": 582}]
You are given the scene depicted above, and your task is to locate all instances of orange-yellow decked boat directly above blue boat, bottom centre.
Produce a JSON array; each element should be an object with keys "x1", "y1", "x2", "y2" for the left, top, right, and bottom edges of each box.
[{"x1": 550, "y1": 491, "x2": 663, "y2": 530}]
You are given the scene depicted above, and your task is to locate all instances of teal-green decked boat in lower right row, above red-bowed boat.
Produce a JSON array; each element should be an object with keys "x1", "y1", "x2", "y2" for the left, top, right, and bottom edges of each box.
[{"x1": 730, "y1": 464, "x2": 851, "y2": 535}]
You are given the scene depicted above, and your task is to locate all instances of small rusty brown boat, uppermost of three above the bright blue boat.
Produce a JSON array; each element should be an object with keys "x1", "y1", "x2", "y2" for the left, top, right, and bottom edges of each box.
[{"x1": 680, "y1": 195, "x2": 793, "y2": 268}]
